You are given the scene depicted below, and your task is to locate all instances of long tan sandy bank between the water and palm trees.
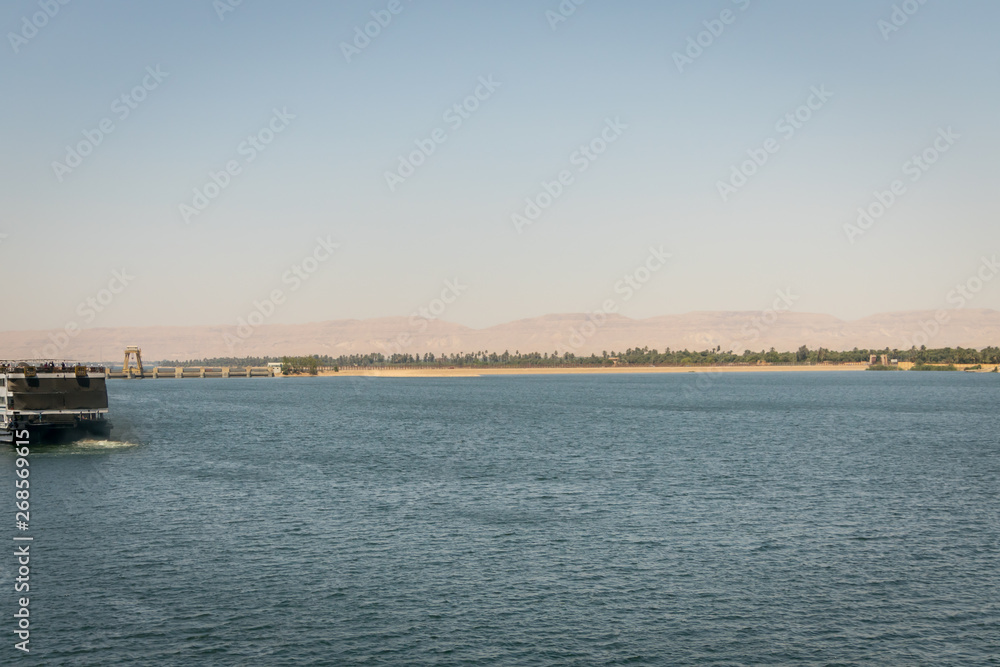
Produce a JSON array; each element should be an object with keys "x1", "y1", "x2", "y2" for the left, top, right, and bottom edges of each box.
[{"x1": 306, "y1": 364, "x2": 867, "y2": 378}]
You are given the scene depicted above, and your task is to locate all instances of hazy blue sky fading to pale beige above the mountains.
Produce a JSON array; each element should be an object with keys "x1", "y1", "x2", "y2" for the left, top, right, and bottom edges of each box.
[{"x1": 0, "y1": 0, "x2": 1000, "y2": 330}]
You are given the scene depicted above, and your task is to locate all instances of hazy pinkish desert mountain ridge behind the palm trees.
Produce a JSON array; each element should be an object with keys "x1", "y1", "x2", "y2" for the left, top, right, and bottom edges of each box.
[{"x1": 0, "y1": 309, "x2": 1000, "y2": 361}]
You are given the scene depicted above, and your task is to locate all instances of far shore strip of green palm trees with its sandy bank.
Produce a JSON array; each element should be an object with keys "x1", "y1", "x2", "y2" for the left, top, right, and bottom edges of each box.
[{"x1": 148, "y1": 345, "x2": 1000, "y2": 377}]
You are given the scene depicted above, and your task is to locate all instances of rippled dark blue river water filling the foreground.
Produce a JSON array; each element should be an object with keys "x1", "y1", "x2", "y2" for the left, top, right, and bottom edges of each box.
[{"x1": 7, "y1": 373, "x2": 1000, "y2": 665}]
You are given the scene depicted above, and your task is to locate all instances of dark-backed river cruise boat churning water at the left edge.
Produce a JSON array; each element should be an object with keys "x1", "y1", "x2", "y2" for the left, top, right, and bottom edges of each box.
[{"x1": 0, "y1": 361, "x2": 111, "y2": 445}]
